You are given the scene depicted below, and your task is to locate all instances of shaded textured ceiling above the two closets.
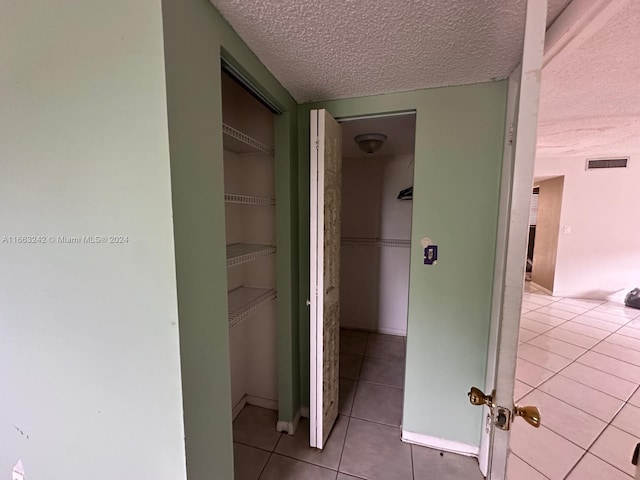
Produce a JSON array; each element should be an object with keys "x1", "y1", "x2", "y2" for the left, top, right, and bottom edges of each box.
[{"x1": 211, "y1": 0, "x2": 569, "y2": 102}]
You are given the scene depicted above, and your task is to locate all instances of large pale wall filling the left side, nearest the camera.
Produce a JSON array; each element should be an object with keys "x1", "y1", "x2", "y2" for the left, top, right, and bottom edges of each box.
[{"x1": 0, "y1": 0, "x2": 186, "y2": 480}]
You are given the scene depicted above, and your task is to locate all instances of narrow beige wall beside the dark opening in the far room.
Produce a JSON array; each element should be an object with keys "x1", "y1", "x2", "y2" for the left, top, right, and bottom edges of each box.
[{"x1": 531, "y1": 177, "x2": 564, "y2": 292}]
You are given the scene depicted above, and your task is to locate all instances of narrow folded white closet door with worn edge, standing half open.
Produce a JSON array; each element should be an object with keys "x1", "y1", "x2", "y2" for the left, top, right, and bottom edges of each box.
[{"x1": 309, "y1": 109, "x2": 342, "y2": 449}]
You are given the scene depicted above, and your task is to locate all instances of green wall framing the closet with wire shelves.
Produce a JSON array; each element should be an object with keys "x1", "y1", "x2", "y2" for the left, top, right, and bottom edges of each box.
[{"x1": 162, "y1": 0, "x2": 300, "y2": 479}]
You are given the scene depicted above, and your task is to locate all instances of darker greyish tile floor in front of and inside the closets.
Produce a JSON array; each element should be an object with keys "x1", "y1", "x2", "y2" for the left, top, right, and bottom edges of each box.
[{"x1": 233, "y1": 330, "x2": 482, "y2": 480}]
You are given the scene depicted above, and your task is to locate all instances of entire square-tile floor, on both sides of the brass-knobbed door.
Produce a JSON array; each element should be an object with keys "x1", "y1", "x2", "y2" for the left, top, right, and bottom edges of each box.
[{"x1": 233, "y1": 283, "x2": 640, "y2": 480}]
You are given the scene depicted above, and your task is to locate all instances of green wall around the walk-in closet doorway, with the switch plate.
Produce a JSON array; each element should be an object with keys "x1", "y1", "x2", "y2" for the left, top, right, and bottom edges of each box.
[{"x1": 299, "y1": 81, "x2": 507, "y2": 445}]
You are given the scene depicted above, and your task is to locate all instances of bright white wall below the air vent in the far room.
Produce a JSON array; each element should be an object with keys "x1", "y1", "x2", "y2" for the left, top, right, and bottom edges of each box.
[{"x1": 534, "y1": 157, "x2": 640, "y2": 298}]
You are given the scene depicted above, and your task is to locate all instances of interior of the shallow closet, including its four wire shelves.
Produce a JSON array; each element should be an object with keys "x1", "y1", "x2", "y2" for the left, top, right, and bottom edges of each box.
[{"x1": 222, "y1": 73, "x2": 278, "y2": 418}]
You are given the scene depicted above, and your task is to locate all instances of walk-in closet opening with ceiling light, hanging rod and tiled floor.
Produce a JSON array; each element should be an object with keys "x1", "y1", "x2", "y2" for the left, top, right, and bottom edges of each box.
[{"x1": 339, "y1": 112, "x2": 416, "y2": 426}]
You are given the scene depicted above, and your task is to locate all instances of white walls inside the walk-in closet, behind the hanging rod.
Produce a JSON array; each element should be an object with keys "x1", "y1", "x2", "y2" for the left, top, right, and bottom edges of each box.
[{"x1": 340, "y1": 155, "x2": 413, "y2": 335}]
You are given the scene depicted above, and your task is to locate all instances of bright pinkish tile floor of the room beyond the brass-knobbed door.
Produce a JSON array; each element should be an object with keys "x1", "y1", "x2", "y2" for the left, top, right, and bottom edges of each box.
[{"x1": 508, "y1": 283, "x2": 640, "y2": 480}]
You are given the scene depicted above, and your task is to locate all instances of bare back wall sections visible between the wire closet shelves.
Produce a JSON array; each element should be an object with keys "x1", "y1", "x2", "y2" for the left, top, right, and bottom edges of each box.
[{"x1": 222, "y1": 75, "x2": 278, "y2": 413}]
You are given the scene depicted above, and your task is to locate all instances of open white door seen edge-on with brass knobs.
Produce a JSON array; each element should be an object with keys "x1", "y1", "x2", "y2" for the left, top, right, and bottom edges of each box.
[{"x1": 470, "y1": 0, "x2": 547, "y2": 480}]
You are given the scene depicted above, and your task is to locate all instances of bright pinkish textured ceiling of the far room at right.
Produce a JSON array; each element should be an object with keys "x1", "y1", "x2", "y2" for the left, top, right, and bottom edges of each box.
[{"x1": 538, "y1": 0, "x2": 640, "y2": 158}]
